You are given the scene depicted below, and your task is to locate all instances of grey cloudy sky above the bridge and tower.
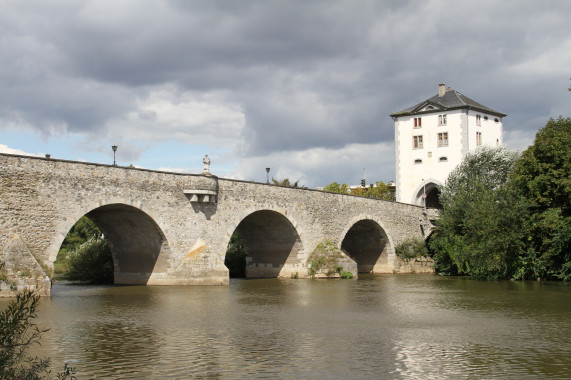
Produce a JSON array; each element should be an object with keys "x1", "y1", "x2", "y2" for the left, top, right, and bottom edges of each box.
[{"x1": 0, "y1": 0, "x2": 571, "y2": 187}]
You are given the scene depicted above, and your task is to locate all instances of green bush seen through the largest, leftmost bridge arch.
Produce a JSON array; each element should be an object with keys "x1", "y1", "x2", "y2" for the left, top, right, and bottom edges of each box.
[{"x1": 66, "y1": 237, "x2": 114, "y2": 284}]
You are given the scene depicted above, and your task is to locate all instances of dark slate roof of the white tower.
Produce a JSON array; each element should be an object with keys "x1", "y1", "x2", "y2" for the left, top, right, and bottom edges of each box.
[{"x1": 390, "y1": 88, "x2": 507, "y2": 117}]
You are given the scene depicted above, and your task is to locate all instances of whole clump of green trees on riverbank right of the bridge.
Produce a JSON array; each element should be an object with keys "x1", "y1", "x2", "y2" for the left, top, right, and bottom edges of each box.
[{"x1": 430, "y1": 117, "x2": 571, "y2": 281}]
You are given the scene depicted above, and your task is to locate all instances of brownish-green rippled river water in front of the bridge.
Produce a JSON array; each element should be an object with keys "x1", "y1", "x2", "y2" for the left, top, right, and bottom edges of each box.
[{"x1": 15, "y1": 275, "x2": 571, "y2": 379}]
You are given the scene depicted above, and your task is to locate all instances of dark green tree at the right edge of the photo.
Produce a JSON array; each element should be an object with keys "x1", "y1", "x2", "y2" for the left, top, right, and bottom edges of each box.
[{"x1": 512, "y1": 117, "x2": 571, "y2": 280}]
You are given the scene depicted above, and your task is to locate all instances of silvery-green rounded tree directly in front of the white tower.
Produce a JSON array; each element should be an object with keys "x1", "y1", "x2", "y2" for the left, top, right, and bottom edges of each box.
[{"x1": 430, "y1": 147, "x2": 526, "y2": 279}]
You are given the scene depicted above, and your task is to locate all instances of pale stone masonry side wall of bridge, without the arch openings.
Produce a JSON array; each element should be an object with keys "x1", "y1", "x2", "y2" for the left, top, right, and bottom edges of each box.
[{"x1": 0, "y1": 154, "x2": 430, "y2": 296}]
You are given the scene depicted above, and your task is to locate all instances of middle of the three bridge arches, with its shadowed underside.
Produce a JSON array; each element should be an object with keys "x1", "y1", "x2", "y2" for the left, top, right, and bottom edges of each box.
[{"x1": 228, "y1": 209, "x2": 304, "y2": 278}]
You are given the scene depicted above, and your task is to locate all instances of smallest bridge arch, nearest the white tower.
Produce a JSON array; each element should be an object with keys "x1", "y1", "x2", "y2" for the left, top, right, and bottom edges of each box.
[{"x1": 339, "y1": 216, "x2": 394, "y2": 273}]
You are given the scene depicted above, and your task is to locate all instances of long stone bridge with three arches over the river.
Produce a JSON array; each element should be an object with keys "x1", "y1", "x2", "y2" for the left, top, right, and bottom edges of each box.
[{"x1": 0, "y1": 154, "x2": 431, "y2": 295}]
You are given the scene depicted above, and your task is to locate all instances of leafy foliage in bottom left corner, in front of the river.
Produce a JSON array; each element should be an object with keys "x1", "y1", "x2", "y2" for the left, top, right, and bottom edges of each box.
[{"x1": 0, "y1": 290, "x2": 75, "y2": 380}]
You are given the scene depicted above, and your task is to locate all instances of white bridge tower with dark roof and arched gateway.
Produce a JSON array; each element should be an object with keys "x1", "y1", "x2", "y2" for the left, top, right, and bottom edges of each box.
[{"x1": 390, "y1": 84, "x2": 507, "y2": 207}]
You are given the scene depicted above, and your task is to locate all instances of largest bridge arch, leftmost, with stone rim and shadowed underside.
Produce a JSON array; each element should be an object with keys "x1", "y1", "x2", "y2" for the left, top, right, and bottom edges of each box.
[{"x1": 49, "y1": 201, "x2": 171, "y2": 284}]
